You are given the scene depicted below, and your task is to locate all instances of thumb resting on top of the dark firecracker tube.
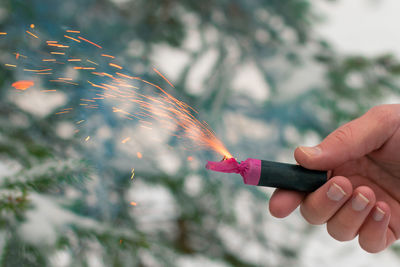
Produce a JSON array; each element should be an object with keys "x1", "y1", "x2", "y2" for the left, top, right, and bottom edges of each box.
[{"x1": 294, "y1": 104, "x2": 400, "y2": 170}]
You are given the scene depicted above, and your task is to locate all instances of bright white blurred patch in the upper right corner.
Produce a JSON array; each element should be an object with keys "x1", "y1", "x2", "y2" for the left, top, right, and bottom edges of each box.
[{"x1": 317, "y1": 0, "x2": 400, "y2": 58}]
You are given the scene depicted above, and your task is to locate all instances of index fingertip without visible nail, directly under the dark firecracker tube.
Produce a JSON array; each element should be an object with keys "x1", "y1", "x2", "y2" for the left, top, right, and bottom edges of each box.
[{"x1": 269, "y1": 189, "x2": 304, "y2": 218}]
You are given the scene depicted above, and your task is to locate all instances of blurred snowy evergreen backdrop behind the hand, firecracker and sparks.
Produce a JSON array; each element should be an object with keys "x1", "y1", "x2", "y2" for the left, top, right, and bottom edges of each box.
[{"x1": 0, "y1": 0, "x2": 400, "y2": 267}]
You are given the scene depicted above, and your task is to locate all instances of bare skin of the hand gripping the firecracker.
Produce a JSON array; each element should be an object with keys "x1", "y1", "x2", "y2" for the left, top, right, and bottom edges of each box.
[{"x1": 269, "y1": 104, "x2": 400, "y2": 253}]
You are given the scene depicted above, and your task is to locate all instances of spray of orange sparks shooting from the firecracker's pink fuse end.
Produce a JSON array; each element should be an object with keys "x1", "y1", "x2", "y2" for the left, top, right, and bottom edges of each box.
[{"x1": 0, "y1": 27, "x2": 232, "y2": 158}]
